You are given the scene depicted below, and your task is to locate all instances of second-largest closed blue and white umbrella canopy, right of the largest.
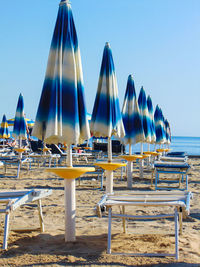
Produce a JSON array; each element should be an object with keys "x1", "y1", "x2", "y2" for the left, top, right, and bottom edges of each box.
[{"x1": 90, "y1": 43, "x2": 124, "y2": 138}]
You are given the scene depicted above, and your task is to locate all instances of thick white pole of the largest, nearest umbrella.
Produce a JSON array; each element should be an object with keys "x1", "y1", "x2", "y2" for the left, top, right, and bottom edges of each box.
[{"x1": 64, "y1": 144, "x2": 76, "y2": 242}]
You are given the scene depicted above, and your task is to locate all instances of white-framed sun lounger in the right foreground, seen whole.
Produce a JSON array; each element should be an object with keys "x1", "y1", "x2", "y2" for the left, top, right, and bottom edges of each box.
[{"x1": 96, "y1": 191, "x2": 192, "y2": 259}]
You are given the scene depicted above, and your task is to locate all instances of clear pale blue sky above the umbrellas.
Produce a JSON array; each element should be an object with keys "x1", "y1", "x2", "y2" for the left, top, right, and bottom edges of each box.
[{"x1": 0, "y1": 0, "x2": 200, "y2": 136}]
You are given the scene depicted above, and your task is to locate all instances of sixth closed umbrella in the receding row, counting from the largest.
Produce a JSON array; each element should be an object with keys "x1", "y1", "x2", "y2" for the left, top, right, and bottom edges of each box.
[{"x1": 154, "y1": 105, "x2": 166, "y2": 145}]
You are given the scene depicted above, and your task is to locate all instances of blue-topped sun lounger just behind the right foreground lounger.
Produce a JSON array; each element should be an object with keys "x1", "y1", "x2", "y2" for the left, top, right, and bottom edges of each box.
[{"x1": 151, "y1": 161, "x2": 190, "y2": 190}]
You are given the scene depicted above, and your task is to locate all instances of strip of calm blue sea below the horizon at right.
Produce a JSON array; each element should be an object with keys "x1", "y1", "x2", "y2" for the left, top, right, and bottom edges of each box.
[{"x1": 125, "y1": 136, "x2": 200, "y2": 156}]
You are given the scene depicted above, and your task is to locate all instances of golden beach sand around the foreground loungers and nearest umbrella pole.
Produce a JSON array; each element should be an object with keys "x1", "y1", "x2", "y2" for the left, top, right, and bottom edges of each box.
[{"x1": 0, "y1": 159, "x2": 200, "y2": 266}]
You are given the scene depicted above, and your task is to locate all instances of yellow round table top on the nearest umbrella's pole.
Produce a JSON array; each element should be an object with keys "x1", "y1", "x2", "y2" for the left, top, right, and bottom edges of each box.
[{"x1": 45, "y1": 167, "x2": 95, "y2": 179}]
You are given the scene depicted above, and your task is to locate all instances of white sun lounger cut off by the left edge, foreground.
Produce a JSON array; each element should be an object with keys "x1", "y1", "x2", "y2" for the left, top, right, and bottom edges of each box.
[{"x1": 0, "y1": 189, "x2": 52, "y2": 249}]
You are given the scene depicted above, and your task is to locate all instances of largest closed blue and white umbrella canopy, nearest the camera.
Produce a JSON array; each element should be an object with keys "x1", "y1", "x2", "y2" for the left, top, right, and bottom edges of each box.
[{"x1": 32, "y1": 0, "x2": 90, "y2": 144}]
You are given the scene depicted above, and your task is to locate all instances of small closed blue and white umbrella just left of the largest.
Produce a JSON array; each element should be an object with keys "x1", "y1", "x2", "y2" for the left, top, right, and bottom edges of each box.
[{"x1": 12, "y1": 94, "x2": 27, "y2": 139}]
